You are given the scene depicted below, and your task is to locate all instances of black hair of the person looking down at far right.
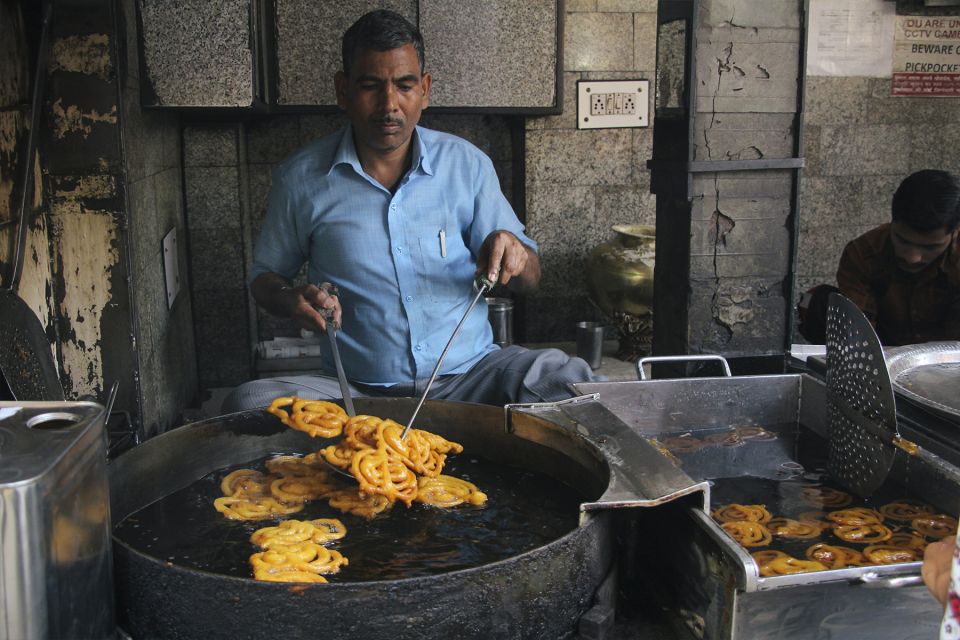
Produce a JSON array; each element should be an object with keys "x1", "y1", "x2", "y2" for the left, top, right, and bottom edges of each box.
[{"x1": 893, "y1": 169, "x2": 960, "y2": 231}]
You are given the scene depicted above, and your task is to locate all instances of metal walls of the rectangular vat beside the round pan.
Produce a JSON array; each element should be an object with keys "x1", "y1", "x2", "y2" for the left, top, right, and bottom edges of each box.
[{"x1": 575, "y1": 374, "x2": 960, "y2": 640}]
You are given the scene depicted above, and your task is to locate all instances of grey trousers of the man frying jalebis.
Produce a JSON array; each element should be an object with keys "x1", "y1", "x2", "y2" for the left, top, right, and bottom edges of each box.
[{"x1": 221, "y1": 345, "x2": 606, "y2": 414}]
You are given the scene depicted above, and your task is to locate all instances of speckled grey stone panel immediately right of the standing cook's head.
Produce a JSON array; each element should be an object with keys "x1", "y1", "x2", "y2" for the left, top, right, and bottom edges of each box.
[{"x1": 426, "y1": 0, "x2": 560, "y2": 107}]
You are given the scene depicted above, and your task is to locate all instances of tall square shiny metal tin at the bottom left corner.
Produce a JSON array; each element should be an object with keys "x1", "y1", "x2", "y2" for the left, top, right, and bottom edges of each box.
[{"x1": 0, "y1": 402, "x2": 116, "y2": 640}]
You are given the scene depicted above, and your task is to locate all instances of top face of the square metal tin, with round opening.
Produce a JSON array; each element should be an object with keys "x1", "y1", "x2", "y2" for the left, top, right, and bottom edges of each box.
[{"x1": 0, "y1": 402, "x2": 104, "y2": 488}]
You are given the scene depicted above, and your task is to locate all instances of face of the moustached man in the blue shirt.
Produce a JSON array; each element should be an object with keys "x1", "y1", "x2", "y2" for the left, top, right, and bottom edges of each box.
[{"x1": 334, "y1": 44, "x2": 431, "y2": 154}]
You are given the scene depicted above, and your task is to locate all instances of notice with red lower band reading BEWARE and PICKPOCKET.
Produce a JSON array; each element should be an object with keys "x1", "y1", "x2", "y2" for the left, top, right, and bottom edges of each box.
[{"x1": 890, "y1": 16, "x2": 960, "y2": 98}]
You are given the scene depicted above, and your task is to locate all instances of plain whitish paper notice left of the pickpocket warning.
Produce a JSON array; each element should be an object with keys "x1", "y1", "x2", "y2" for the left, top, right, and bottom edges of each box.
[{"x1": 807, "y1": 0, "x2": 896, "y2": 78}]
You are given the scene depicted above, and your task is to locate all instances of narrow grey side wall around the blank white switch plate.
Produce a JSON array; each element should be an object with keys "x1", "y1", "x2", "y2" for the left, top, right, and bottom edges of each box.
[{"x1": 118, "y1": 0, "x2": 198, "y2": 436}]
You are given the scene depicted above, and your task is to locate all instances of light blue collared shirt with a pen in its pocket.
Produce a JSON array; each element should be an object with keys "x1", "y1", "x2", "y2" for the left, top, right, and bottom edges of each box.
[{"x1": 250, "y1": 127, "x2": 537, "y2": 385}]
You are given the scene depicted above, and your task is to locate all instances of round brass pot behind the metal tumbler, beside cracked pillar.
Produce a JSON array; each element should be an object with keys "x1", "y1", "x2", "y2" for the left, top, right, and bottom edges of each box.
[{"x1": 587, "y1": 224, "x2": 656, "y2": 317}]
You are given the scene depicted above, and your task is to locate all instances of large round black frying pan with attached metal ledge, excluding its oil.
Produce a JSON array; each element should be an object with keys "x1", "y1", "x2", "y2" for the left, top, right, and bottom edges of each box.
[{"x1": 110, "y1": 398, "x2": 705, "y2": 640}]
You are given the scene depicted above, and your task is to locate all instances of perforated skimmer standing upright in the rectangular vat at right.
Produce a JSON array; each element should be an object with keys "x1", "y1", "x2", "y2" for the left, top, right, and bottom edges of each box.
[{"x1": 827, "y1": 293, "x2": 957, "y2": 497}]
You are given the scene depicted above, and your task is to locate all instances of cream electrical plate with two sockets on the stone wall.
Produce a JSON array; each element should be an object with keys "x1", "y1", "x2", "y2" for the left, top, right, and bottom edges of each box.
[{"x1": 577, "y1": 80, "x2": 650, "y2": 129}]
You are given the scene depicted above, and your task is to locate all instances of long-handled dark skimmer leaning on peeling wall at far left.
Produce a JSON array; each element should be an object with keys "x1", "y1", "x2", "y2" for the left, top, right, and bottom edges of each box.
[{"x1": 0, "y1": 2, "x2": 63, "y2": 401}]
